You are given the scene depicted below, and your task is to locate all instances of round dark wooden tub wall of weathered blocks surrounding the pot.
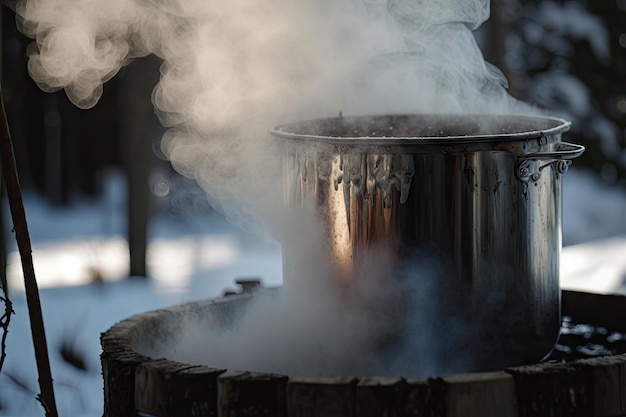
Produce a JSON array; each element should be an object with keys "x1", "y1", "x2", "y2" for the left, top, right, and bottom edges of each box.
[{"x1": 101, "y1": 290, "x2": 626, "y2": 417}]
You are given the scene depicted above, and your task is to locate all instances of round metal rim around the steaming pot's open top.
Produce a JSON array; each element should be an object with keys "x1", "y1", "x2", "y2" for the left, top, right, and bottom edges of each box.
[{"x1": 269, "y1": 113, "x2": 571, "y2": 145}]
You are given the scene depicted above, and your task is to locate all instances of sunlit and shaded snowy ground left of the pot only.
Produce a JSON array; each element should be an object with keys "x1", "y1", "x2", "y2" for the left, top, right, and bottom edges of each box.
[{"x1": 0, "y1": 173, "x2": 282, "y2": 417}]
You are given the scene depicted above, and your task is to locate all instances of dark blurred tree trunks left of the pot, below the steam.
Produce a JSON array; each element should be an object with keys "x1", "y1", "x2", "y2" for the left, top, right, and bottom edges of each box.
[{"x1": 1, "y1": 8, "x2": 163, "y2": 276}]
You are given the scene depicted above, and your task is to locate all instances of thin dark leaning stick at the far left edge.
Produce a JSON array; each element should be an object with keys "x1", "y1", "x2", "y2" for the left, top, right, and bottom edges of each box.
[{"x1": 0, "y1": 89, "x2": 58, "y2": 417}]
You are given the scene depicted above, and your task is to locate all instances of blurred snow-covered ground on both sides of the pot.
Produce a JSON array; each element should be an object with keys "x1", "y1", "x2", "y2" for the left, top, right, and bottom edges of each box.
[{"x1": 0, "y1": 169, "x2": 626, "y2": 417}]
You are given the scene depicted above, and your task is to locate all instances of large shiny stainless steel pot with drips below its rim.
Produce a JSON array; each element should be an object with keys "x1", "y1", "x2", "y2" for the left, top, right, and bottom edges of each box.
[{"x1": 271, "y1": 114, "x2": 584, "y2": 371}]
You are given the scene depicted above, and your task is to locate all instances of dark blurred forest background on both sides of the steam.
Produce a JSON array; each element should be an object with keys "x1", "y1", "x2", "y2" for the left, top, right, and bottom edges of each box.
[{"x1": 1, "y1": 0, "x2": 626, "y2": 282}]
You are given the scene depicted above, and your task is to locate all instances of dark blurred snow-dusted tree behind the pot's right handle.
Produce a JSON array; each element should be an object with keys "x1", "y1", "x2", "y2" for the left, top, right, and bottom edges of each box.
[{"x1": 498, "y1": 0, "x2": 626, "y2": 187}]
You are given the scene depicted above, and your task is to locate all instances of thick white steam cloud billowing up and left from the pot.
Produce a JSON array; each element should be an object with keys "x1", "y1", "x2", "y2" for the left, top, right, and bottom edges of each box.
[{"x1": 17, "y1": 0, "x2": 521, "y2": 376}]
